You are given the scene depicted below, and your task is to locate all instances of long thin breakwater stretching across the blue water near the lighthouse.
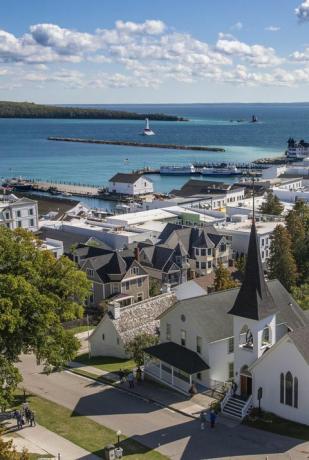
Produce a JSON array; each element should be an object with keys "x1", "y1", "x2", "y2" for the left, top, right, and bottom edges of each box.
[{"x1": 47, "y1": 136, "x2": 225, "y2": 152}]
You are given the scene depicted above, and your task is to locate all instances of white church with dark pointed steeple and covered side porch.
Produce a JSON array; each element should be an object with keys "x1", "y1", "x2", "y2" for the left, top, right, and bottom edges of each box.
[{"x1": 145, "y1": 220, "x2": 309, "y2": 425}]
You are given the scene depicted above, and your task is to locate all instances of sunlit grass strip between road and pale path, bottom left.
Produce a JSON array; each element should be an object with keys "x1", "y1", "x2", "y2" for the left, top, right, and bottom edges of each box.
[{"x1": 12, "y1": 393, "x2": 168, "y2": 460}]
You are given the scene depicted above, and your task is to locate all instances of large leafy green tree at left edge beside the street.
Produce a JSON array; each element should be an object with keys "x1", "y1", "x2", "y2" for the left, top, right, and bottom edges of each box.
[{"x1": 0, "y1": 227, "x2": 90, "y2": 404}]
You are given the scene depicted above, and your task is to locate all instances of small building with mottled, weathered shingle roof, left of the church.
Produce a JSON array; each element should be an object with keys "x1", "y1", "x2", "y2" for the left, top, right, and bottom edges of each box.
[{"x1": 89, "y1": 293, "x2": 176, "y2": 358}]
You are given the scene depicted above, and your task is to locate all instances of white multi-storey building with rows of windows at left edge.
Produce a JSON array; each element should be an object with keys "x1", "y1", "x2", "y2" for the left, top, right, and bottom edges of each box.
[{"x1": 0, "y1": 195, "x2": 39, "y2": 232}]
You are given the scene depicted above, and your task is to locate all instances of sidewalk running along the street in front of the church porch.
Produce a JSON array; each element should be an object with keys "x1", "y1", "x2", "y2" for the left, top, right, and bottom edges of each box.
[{"x1": 69, "y1": 362, "x2": 216, "y2": 418}]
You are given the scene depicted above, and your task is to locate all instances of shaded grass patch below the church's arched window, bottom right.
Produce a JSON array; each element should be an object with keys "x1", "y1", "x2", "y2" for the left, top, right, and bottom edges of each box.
[{"x1": 246, "y1": 412, "x2": 309, "y2": 441}]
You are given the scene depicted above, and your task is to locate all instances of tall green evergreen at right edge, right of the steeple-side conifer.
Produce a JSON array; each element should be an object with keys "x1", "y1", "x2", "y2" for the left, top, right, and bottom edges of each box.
[{"x1": 285, "y1": 201, "x2": 309, "y2": 283}]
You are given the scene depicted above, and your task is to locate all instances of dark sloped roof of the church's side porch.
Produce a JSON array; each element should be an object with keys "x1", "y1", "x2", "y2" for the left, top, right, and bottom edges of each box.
[{"x1": 145, "y1": 342, "x2": 209, "y2": 375}]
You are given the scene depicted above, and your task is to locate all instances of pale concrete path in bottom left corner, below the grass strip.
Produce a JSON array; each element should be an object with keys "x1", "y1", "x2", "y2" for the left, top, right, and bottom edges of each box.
[{"x1": 5, "y1": 420, "x2": 100, "y2": 460}]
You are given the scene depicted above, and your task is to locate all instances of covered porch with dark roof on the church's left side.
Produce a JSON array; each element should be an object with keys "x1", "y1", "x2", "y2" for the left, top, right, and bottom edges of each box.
[{"x1": 145, "y1": 342, "x2": 209, "y2": 395}]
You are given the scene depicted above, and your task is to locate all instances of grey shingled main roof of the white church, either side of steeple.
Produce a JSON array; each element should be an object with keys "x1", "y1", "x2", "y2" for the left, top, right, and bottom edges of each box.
[{"x1": 161, "y1": 280, "x2": 309, "y2": 342}]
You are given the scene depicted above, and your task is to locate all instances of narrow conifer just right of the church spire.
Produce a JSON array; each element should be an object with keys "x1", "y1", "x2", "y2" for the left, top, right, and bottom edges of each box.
[{"x1": 268, "y1": 225, "x2": 297, "y2": 291}]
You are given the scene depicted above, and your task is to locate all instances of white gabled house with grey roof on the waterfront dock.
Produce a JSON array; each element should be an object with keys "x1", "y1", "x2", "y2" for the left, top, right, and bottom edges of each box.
[{"x1": 108, "y1": 173, "x2": 153, "y2": 196}]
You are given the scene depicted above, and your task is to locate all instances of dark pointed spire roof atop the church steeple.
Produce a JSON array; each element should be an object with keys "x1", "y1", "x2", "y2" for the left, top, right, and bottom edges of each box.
[{"x1": 229, "y1": 222, "x2": 278, "y2": 320}]
